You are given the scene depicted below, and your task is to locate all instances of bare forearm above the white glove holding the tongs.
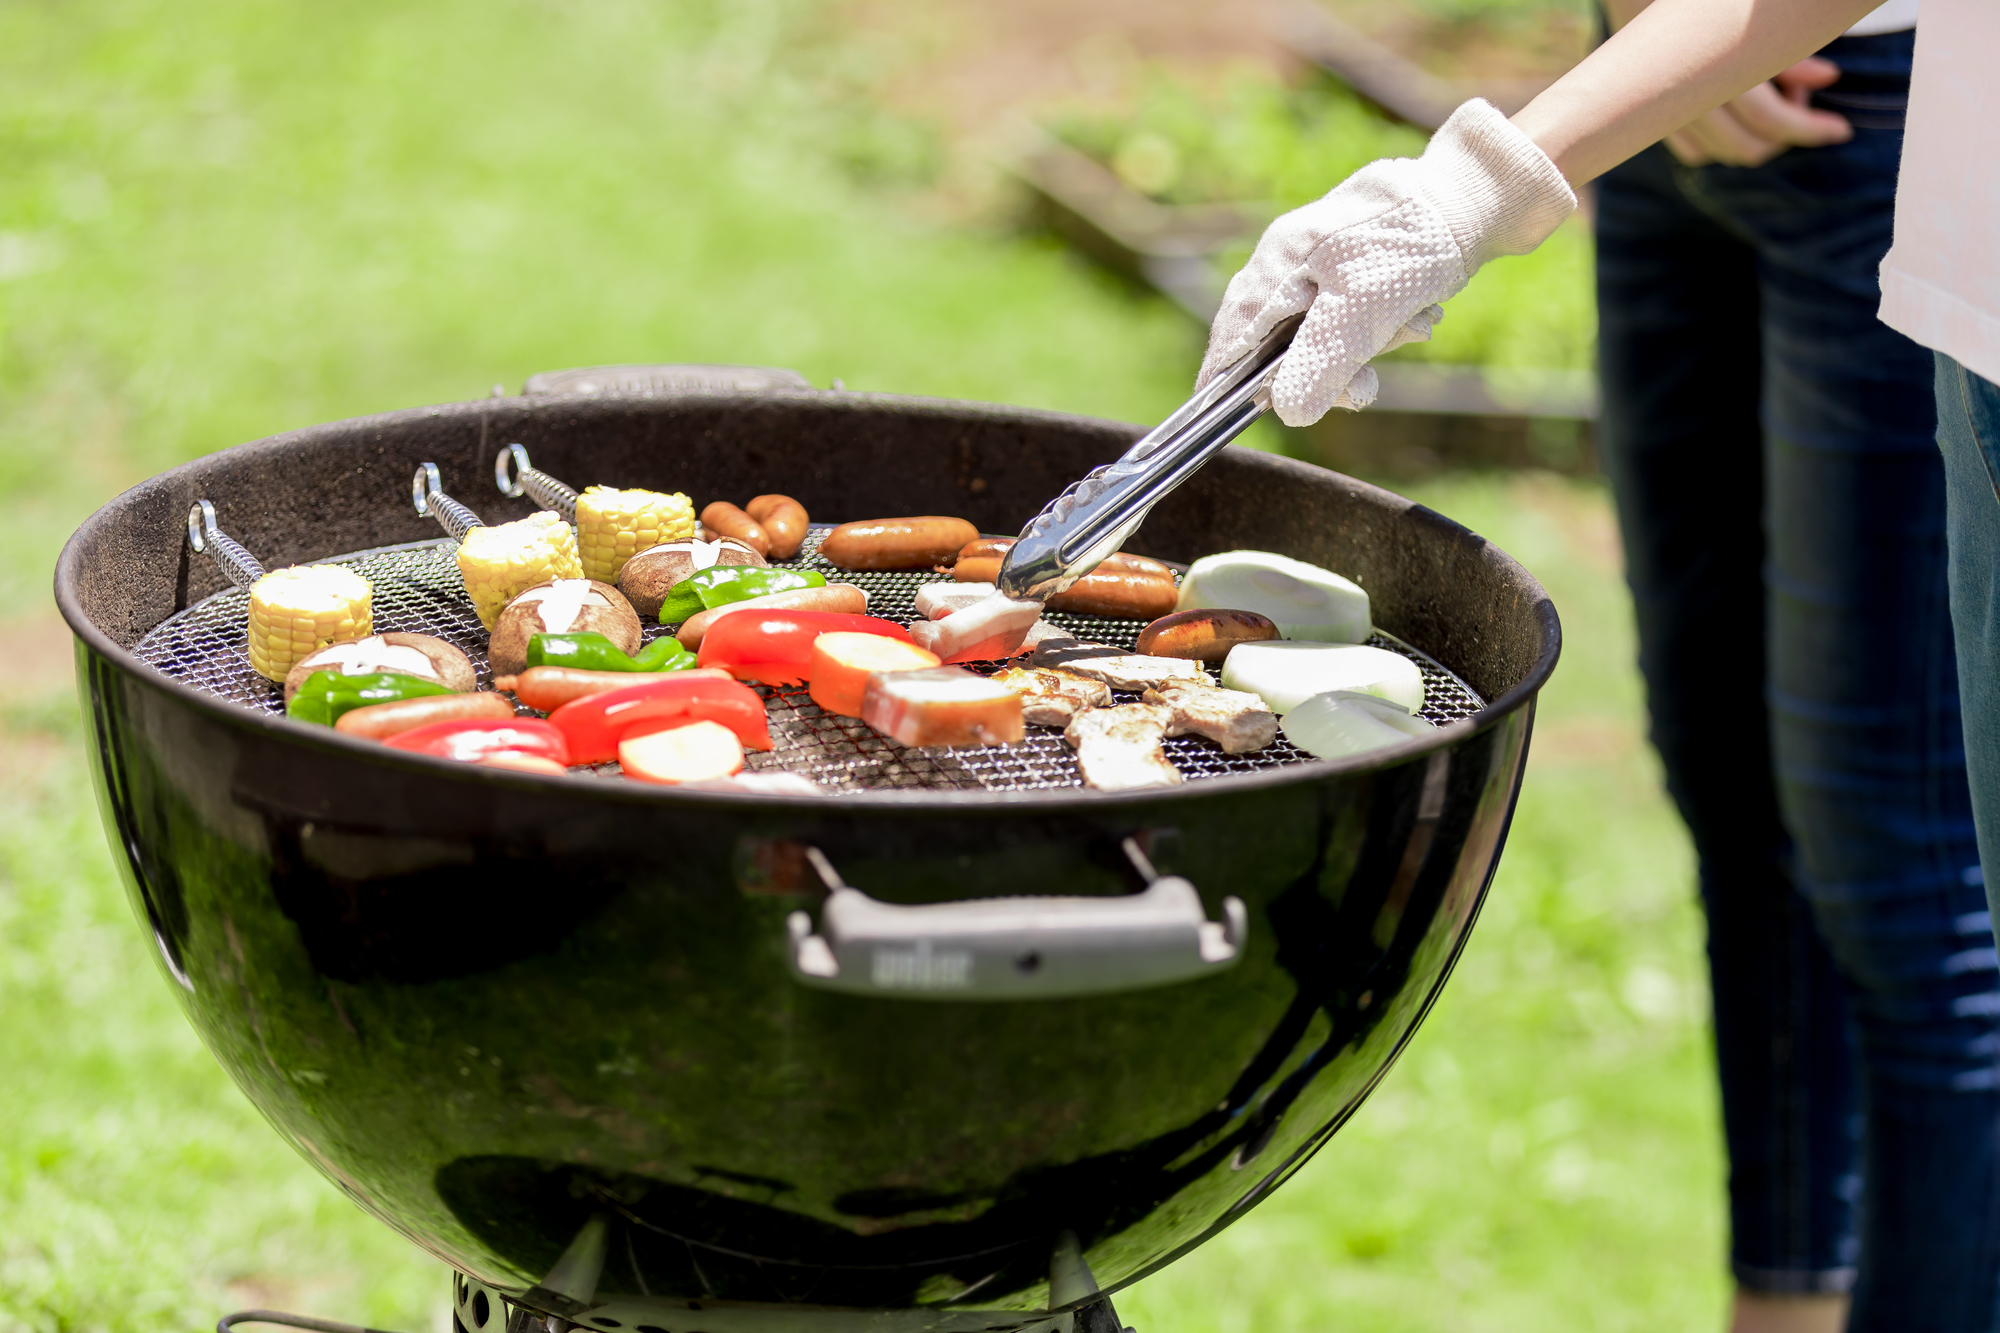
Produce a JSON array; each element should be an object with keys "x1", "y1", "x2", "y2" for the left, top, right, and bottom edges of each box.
[{"x1": 1514, "y1": 0, "x2": 1880, "y2": 184}]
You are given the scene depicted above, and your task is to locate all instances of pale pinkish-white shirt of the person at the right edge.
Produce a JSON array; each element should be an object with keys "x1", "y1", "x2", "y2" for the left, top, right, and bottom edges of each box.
[{"x1": 1882, "y1": 0, "x2": 2000, "y2": 380}]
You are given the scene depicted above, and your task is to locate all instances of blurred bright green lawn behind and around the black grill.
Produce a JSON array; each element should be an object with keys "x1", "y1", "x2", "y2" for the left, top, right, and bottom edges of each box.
[{"x1": 0, "y1": 0, "x2": 1722, "y2": 1333}]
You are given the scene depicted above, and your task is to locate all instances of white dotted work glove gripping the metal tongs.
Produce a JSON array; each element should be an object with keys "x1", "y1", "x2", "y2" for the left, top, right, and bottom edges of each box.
[{"x1": 1194, "y1": 100, "x2": 1576, "y2": 426}]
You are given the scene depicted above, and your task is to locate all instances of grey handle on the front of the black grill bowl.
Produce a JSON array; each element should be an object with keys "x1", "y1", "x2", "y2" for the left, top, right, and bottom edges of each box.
[{"x1": 786, "y1": 839, "x2": 1250, "y2": 1001}]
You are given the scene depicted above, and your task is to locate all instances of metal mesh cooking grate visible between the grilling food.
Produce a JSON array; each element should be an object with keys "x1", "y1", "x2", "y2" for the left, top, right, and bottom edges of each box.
[{"x1": 134, "y1": 526, "x2": 1484, "y2": 791}]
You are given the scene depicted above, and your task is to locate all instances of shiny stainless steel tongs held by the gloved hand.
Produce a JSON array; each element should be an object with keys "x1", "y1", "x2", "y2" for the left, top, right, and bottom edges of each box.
[{"x1": 998, "y1": 314, "x2": 1304, "y2": 602}]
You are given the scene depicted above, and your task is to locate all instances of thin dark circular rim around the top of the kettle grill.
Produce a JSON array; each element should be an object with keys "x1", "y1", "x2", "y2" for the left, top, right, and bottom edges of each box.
[{"x1": 54, "y1": 378, "x2": 1562, "y2": 815}]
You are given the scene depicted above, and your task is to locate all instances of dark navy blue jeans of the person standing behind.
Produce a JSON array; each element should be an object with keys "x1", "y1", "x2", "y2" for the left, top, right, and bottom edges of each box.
[{"x1": 1598, "y1": 34, "x2": 2000, "y2": 1333}]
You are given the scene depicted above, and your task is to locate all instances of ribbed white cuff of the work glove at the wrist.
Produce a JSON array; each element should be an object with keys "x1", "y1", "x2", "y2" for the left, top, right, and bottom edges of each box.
[{"x1": 1418, "y1": 98, "x2": 1576, "y2": 276}]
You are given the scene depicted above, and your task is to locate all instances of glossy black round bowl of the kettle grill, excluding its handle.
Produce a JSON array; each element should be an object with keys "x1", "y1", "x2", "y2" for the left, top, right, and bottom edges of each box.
[{"x1": 56, "y1": 392, "x2": 1558, "y2": 1333}]
